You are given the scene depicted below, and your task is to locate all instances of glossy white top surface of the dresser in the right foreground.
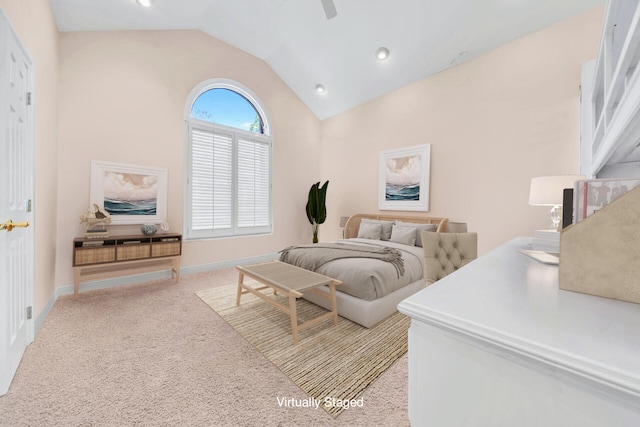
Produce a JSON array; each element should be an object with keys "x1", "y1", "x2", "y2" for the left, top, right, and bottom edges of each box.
[{"x1": 398, "y1": 237, "x2": 640, "y2": 398}]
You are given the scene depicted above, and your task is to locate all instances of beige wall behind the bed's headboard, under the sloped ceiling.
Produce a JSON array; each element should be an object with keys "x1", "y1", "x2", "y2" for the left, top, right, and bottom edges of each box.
[{"x1": 320, "y1": 8, "x2": 603, "y2": 253}]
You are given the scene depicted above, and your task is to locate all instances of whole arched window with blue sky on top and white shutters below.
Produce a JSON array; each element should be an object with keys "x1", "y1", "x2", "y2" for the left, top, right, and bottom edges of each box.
[{"x1": 185, "y1": 79, "x2": 273, "y2": 239}]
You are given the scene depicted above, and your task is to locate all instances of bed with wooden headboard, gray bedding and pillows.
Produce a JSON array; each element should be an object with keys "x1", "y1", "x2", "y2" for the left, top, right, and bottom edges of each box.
[{"x1": 280, "y1": 214, "x2": 448, "y2": 328}]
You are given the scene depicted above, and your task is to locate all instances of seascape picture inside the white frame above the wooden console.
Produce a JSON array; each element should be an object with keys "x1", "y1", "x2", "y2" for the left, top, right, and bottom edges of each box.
[{"x1": 104, "y1": 171, "x2": 158, "y2": 215}]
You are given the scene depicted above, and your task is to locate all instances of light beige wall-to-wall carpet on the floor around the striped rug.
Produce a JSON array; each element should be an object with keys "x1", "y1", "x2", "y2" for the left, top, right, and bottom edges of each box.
[{"x1": 0, "y1": 268, "x2": 409, "y2": 427}]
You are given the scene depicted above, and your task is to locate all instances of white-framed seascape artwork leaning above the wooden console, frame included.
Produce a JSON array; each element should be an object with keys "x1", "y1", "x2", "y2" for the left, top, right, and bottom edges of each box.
[{"x1": 90, "y1": 160, "x2": 168, "y2": 225}]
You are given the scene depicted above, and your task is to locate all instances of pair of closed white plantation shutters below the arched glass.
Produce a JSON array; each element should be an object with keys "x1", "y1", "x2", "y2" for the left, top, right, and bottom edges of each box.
[{"x1": 186, "y1": 121, "x2": 272, "y2": 238}]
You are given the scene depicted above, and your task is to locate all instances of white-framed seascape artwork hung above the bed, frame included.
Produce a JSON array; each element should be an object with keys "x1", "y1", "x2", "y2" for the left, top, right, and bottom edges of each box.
[{"x1": 378, "y1": 144, "x2": 431, "y2": 212}]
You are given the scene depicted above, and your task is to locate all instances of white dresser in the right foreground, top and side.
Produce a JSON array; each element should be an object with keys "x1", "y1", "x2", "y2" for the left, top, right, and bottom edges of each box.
[{"x1": 398, "y1": 238, "x2": 640, "y2": 427}]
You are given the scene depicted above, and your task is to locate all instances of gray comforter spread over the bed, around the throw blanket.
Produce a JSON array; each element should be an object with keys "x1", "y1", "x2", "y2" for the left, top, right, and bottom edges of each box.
[{"x1": 282, "y1": 238, "x2": 424, "y2": 301}]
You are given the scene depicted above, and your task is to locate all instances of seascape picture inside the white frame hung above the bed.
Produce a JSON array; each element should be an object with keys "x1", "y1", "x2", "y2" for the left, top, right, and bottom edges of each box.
[{"x1": 385, "y1": 156, "x2": 422, "y2": 201}]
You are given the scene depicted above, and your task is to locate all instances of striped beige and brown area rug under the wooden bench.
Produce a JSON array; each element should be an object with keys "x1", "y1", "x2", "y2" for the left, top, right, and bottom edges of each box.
[{"x1": 196, "y1": 280, "x2": 410, "y2": 418}]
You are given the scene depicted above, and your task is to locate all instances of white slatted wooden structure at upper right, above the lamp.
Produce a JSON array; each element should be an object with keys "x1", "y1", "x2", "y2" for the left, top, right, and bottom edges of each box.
[{"x1": 580, "y1": 0, "x2": 640, "y2": 178}]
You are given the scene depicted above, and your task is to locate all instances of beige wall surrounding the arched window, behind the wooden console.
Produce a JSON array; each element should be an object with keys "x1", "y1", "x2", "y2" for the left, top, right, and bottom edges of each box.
[{"x1": 56, "y1": 31, "x2": 320, "y2": 286}]
